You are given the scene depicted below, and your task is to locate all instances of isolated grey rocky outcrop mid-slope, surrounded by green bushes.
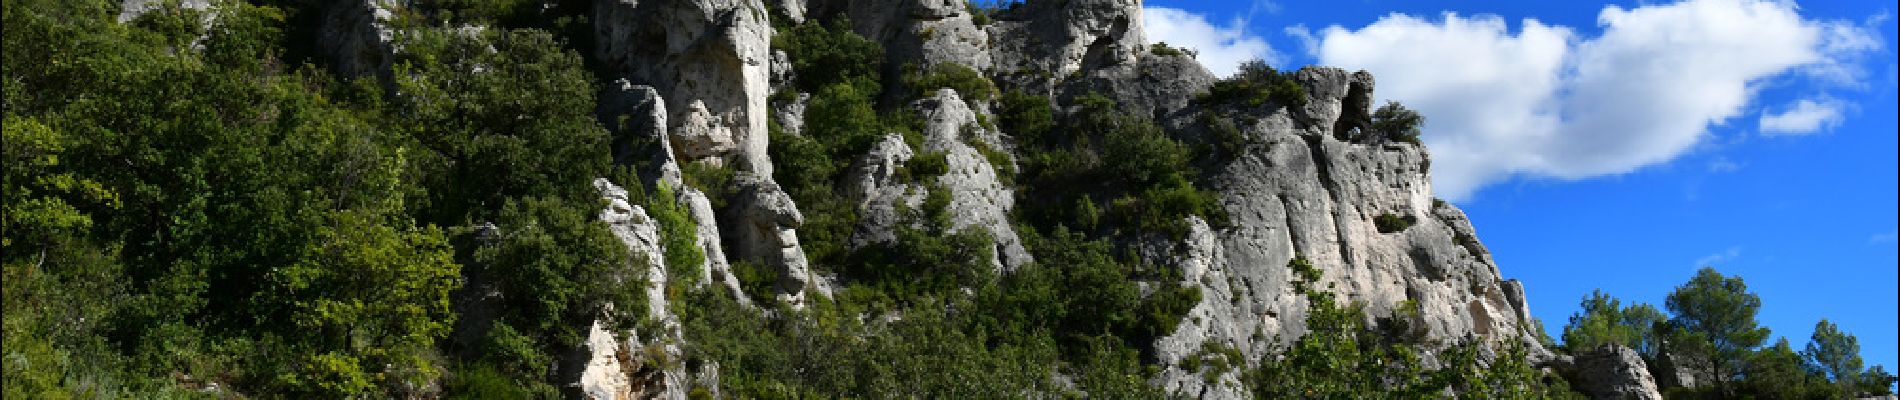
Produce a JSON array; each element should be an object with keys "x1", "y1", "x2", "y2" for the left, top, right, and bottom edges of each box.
[{"x1": 846, "y1": 89, "x2": 1030, "y2": 269}]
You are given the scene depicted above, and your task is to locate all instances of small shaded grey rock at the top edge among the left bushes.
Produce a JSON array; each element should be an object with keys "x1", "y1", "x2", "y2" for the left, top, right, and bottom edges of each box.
[{"x1": 317, "y1": 0, "x2": 395, "y2": 81}]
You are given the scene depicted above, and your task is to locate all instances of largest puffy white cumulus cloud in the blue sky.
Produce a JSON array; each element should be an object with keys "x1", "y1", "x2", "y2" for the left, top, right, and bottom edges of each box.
[{"x1": 1313, "y1": 0, "x2": 1881, "y2": 199}]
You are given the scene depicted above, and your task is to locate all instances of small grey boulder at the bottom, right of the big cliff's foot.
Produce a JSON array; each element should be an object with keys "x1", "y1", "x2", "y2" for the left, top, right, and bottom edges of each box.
[{"x1": 1558, "y1": 345, "x2": 1663, "y2": 400}]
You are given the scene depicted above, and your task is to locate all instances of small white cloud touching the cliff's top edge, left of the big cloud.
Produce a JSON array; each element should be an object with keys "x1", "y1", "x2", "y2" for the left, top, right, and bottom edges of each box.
[{"x1": 1142, "y1": 2, "x2": 1279, "y2": 76}]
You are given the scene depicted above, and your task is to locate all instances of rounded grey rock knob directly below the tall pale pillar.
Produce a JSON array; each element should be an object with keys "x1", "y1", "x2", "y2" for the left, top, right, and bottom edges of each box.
[{"x1": 720, "y1": 173, "x2": 830, "y2": 307}]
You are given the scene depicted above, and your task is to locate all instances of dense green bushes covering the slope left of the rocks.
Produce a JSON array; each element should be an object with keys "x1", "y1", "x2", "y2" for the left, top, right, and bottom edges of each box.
[{"x1": 0, "y1": 0, "x2": 635, "y2": 398}]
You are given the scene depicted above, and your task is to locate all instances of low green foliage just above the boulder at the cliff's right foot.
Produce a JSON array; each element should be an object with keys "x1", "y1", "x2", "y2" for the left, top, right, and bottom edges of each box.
[{"x1": 1564, "y1": 290, "x2": 1666, "y2": 362}]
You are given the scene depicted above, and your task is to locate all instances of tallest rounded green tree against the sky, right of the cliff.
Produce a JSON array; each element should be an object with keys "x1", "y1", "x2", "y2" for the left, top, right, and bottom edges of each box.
[{"x1": 1664, "y1": 267, "x2": 1769, "y2": 394}]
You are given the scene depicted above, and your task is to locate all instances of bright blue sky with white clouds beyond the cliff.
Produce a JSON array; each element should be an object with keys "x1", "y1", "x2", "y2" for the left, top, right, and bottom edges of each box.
[{"x1": 1144, "y1": 0, "x2": 1900, "y2": 372}]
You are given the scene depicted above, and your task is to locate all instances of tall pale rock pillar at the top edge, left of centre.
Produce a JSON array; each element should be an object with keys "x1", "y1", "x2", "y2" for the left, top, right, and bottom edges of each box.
[{"x1": 595, "y1": 0, "x2": 771, "y2": 176}]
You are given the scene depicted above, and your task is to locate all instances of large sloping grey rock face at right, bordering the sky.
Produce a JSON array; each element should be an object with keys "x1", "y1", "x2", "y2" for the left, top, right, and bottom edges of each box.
[{"x1": 1155, "y1": 68, "x2": 1547, "y2": 396}]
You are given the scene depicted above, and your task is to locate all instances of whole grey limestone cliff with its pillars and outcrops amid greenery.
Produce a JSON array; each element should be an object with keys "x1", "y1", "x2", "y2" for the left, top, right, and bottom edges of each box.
[{"x1": 595, "y1": 0, "x2": 1547, "y2": 398}]
